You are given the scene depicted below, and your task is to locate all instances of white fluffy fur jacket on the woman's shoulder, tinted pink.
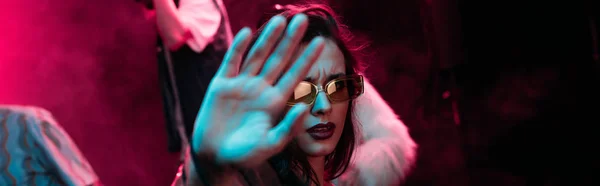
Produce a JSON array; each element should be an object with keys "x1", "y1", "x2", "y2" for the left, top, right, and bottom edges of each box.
[{"x1": 334, "y1": 76, "x2": 417, "y2": 186}]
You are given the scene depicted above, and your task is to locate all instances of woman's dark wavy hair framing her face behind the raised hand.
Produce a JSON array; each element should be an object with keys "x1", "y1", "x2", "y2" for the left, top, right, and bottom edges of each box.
[{"x1": 246, "y1": 3, "x2": 365, "y2": 185}]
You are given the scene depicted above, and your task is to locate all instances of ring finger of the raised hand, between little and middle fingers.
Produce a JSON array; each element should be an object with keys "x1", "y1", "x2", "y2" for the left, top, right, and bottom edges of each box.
[{"x1": 242, "y1": 16, "x2": 286, "y2": 76}]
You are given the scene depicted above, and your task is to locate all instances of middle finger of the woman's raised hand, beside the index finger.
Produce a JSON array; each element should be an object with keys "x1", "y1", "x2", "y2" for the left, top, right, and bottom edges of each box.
[{"x1": 260, "y1": 14, "x2": 308, "y2": 84}]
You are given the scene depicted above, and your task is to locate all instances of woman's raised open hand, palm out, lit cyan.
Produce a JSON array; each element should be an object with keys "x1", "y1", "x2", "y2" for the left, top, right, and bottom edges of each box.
[{"x1": 192, "y1": 14, "x2": 324, "y2": 167}]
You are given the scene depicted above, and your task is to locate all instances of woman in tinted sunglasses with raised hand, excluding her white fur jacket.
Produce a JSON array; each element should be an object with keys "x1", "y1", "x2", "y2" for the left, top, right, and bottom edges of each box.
[{"x1": 176, "y1": 5, "x2": 414, "y2": 185}]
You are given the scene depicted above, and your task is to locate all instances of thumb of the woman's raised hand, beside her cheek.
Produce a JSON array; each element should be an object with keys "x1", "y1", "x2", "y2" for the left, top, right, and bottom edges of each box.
[{"x1": 267, "y1": 104, "x2": 310, "y2": 154}]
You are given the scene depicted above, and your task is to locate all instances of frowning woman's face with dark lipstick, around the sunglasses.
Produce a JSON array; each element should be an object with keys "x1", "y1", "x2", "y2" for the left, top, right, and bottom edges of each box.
[{"x1": 295, "y1": 39, "x2": 349, "y2": 157}]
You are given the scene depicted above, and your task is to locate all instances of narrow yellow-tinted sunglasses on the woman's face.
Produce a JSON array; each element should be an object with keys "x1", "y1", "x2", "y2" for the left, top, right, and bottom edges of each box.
[{"x1": 287, "y1": 75, "x2": 364, "y2": 106}]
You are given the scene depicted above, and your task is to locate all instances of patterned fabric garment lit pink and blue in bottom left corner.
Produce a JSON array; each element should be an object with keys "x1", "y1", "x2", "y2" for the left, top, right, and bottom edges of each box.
[{"x1": 0, "y1": 105, "x2": 99, "y2": 186}]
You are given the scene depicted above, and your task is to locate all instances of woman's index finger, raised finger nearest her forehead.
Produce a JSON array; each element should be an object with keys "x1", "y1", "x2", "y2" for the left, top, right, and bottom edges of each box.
[{"x1": 275, "y1": 36, "x2": 325, "y2": 97}]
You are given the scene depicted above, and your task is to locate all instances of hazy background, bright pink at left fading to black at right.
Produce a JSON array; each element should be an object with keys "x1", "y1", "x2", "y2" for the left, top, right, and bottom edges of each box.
[{"x1": 0, "y1": 0, "x2": 600, "y2": 186}]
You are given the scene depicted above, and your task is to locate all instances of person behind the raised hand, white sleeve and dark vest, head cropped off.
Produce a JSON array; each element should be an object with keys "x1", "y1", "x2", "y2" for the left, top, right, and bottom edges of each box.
[{"x1": 144, "y1": 0, "x2": 232, "y2": 155}]
